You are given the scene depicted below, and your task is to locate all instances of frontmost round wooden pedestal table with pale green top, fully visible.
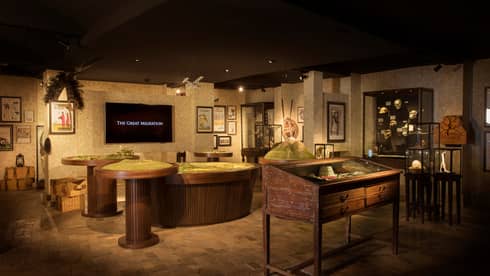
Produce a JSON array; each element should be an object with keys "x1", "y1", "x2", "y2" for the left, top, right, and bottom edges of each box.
[{"x1": 96, "y1": 160, "x2": 177, "y2": 249}]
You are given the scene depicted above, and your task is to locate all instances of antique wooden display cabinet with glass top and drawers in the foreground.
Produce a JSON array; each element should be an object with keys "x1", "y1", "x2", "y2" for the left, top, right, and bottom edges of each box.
[{"x1": 262, "y1": 158, "x2": 400, "y2": 275}]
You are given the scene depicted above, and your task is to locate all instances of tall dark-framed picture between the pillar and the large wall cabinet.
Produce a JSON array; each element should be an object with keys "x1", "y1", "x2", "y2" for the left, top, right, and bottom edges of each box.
[{"x1": 327, "y1": 102, "x2": 345, "y2": 142}]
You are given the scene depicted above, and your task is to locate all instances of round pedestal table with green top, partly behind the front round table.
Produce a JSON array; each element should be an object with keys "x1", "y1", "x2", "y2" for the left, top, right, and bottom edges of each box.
[{"x1": 61, "y1": 155, "x2": 139, "y2": 218}]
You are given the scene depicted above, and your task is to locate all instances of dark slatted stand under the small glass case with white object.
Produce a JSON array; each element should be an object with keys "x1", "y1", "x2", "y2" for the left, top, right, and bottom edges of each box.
[{"x1": 405, "y1": 172, "x2": 433, "y2": 223}]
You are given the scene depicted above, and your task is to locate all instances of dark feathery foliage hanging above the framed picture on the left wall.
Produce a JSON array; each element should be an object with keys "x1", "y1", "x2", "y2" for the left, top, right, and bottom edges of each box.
[{"x1": 44, "y1": 72, "x2": 84, "y2": 110}]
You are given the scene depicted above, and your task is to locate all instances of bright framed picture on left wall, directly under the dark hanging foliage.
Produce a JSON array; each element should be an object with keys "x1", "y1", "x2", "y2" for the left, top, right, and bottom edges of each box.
[{"x1": 49, "y1": 101, "x2": 75, "y2": 134}]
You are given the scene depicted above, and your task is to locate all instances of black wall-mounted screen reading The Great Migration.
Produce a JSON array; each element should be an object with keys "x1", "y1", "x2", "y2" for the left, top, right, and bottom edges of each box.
[{"x1": 105, "y1": 102, "x2": 173, "y2": 143}]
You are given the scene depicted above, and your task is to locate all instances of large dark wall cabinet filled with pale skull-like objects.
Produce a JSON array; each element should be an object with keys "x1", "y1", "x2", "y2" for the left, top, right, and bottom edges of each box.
[{"x1": 363, "y1": 88, "x2": 433, "y2": 157}]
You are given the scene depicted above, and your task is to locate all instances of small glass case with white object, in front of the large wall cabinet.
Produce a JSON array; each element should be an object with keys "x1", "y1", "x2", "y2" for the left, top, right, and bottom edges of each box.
[{"x1": 405, "y1": 122, "x2": 440, "y2": 173}]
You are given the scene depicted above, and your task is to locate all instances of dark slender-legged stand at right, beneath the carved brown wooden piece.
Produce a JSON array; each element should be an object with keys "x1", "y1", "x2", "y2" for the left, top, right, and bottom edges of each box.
[{"x1": 434, "y1": 173, "x2": 461, "y2": 225}]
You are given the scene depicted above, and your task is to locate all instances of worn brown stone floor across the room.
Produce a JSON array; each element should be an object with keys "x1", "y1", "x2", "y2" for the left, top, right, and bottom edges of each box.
[{"x1": 0, "y1": 189, "x2": 490, "y2": 276}]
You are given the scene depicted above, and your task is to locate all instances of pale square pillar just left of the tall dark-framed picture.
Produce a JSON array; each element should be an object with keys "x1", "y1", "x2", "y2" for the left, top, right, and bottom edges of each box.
[{"x1": 303, "y1": 71, "x2": 323, "y2": 152}]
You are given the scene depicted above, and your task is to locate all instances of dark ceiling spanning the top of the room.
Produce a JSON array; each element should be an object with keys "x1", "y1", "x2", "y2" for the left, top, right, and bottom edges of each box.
[{"x1": 0, "y1": 0, "x2": 490, "y2": 88}]
